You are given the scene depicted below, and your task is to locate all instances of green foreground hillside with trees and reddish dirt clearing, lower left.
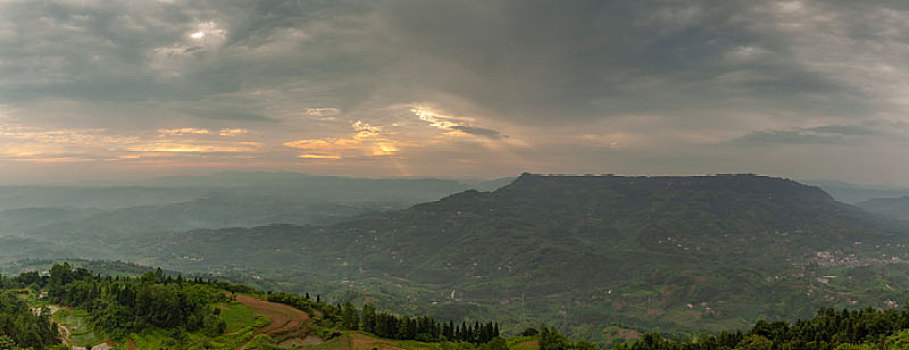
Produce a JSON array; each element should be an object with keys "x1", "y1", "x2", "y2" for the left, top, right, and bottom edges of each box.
[{"x1": 0, "y1": 263, "x2": 510, "y2": 349}]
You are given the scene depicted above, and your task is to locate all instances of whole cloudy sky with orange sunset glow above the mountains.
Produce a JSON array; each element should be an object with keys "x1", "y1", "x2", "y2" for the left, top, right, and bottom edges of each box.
[{"x1": 0, "y1": 0, "x2": 909, "y2": 185}]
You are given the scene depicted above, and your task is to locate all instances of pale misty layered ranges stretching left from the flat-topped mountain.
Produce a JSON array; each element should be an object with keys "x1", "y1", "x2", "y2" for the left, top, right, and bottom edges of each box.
[{"x1": 0, "y1": 172, "x2": 501, "y2": 241}]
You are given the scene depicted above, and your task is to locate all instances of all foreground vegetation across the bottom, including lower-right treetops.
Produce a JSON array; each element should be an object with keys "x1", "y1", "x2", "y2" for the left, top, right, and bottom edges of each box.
[{"x1": 0, "y1": 264, "x2": 909, "y2": 350}]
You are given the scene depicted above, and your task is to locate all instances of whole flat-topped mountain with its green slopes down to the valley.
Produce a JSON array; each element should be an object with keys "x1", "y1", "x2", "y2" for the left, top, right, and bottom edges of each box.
[{"x1": 126, "y1": 174, "x2": 909, "y2": 338}]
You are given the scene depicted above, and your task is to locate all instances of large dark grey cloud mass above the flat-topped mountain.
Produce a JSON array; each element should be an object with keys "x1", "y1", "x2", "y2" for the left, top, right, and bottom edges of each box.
[{"x1": 370, "y1": 1, "x2": 861, "y2": 123}]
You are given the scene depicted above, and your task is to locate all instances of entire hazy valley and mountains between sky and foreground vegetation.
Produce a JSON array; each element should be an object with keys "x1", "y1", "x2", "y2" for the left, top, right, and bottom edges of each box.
[{"x1": 0, "y1": 172, "x2": 909, "y2": 343}]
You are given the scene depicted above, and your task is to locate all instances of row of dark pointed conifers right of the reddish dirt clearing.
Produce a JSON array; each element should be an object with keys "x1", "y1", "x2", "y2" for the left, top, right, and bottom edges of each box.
[{"x1": 268, "y1": 293, "x2": 499, "y2": 344}]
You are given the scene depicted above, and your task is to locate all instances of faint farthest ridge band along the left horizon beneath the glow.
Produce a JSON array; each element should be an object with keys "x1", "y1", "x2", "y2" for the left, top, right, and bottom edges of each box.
[{"x1": 0, "y1": 172, "x2": 484, "y2": 210}]
